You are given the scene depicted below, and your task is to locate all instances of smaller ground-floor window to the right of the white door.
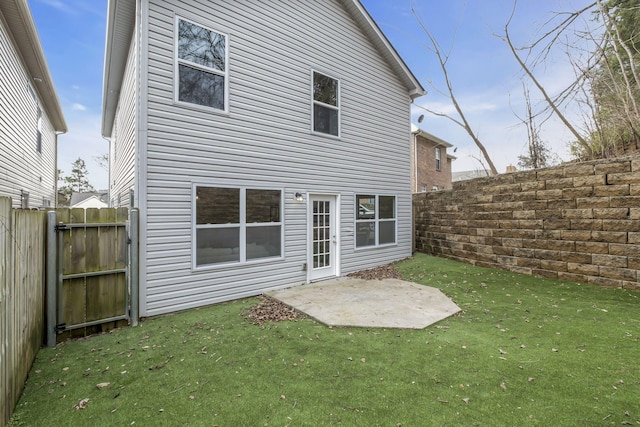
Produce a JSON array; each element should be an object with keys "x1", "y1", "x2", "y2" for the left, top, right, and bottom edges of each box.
[{"x1": 355, "y1": 194, "x2": 397, "y2": 248}]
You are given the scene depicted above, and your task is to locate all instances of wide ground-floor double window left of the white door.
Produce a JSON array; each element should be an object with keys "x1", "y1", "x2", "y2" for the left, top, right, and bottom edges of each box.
[{"x1": 194, "y1": 186, "x2": 282, "y2": 267}]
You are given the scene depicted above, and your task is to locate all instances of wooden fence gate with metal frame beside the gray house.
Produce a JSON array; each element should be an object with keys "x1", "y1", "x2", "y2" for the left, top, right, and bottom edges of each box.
[{"x1": 47, "y1": 208, "x2": 138, "y2": 346}]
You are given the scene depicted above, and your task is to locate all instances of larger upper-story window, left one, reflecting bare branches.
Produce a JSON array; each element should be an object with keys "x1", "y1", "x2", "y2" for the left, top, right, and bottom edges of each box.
[{"x1": 175, "y1": 18, "x2": 228, "y2": 111}]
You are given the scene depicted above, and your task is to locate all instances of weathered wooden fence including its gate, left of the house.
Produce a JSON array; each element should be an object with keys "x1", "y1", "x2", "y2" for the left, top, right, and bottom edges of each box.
[{"x1": 0, "y1": 201, "x2": 138, "y2": 427}]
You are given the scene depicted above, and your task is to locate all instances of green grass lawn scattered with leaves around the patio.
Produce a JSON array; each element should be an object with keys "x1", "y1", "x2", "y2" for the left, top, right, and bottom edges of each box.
[{"x1": 10, "y1": 254, "x2": 640, "y2": 427}]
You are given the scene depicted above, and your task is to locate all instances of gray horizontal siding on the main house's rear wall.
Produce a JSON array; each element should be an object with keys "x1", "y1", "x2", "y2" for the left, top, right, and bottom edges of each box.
[{"x1": 141, "y1": 0, "x2": 411, "y2": 315}]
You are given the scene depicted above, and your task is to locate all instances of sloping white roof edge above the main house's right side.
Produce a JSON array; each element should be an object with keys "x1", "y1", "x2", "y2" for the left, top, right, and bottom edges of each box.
[{"x1": 341, "y1": 0, "x2": 427, "y2": 100}]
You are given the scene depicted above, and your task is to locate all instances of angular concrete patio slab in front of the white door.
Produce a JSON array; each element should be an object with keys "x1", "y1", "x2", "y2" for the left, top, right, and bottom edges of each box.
[{"x1": 266, "y1": 277, "x2": 460, "y2": 329}]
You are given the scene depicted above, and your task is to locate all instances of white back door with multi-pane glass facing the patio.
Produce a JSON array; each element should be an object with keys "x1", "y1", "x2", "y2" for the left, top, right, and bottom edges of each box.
[{"x1": 307, "y1": 195, "x2": 338, "y2": 282}]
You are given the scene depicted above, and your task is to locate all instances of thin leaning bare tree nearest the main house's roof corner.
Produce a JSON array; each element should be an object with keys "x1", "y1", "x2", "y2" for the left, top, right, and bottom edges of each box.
[{"x1": 411, "y1": 0, "x2": 498, "y2": 175}]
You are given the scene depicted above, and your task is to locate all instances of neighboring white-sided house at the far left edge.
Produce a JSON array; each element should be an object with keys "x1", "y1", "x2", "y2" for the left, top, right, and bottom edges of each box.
[{"x1": 0, "y1": 0, "x2": 67, "y2": 209}]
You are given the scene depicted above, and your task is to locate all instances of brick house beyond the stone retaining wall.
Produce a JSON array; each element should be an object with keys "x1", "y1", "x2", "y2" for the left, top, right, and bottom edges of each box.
[{"x1": 411, "y1": 125, "x2": 456, "y2": 193}]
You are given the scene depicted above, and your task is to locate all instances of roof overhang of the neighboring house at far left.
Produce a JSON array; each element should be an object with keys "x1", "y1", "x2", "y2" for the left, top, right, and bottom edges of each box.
[{"x1": 0, "y1": 0, "x2": 67, "y2": 133}]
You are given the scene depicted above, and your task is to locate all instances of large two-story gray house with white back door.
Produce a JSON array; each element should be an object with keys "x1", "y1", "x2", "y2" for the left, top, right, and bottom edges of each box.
[{"x1": 103, "y1": 0, "x2": 424, "y2": 316}]
